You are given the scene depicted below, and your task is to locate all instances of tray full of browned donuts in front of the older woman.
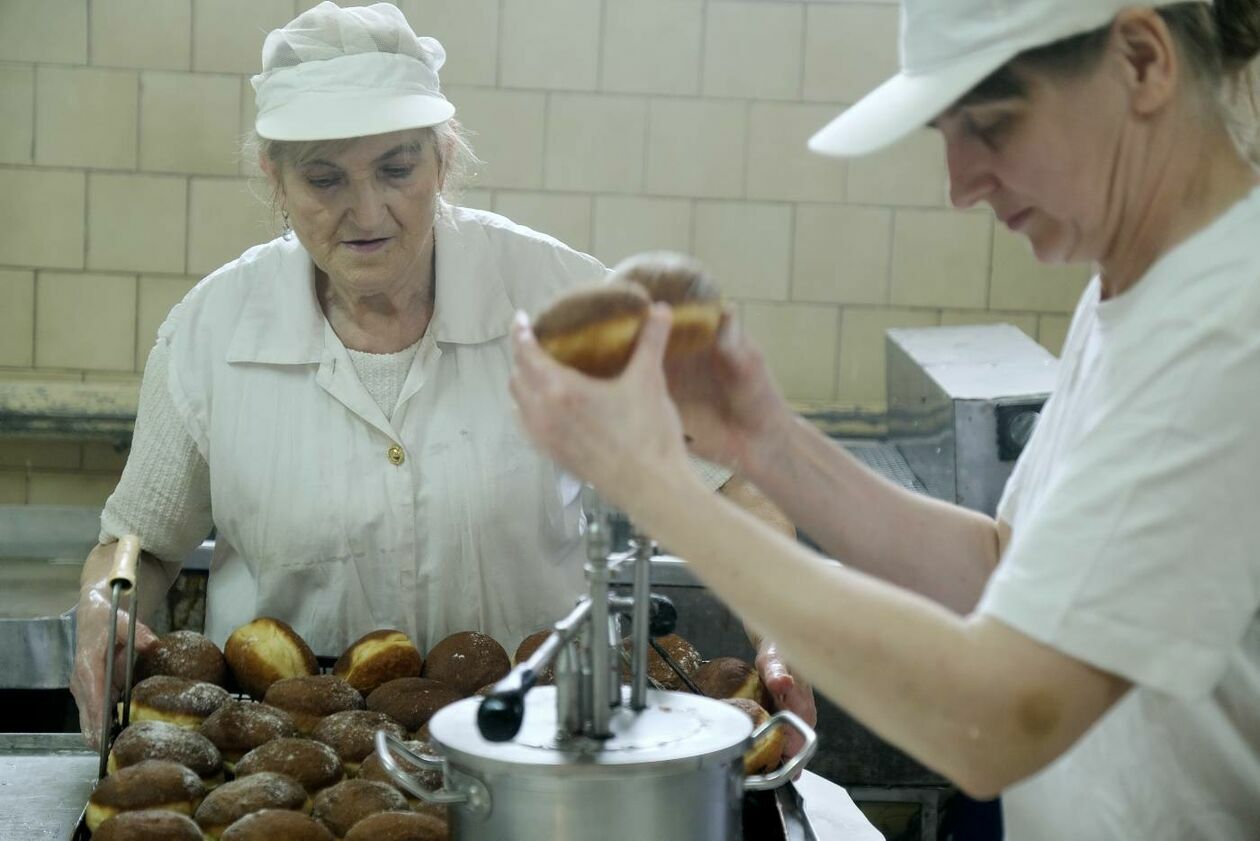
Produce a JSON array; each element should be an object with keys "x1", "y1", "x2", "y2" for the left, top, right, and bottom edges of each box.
[{"x1": 71, "y1": 618, "x2": 529, "y2": 841}]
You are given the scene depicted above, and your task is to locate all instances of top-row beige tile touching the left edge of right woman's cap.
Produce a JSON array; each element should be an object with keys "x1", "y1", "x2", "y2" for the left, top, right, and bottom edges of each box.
[{"x1": 805, "y1": 3, "x2": 898, "y2": 103}]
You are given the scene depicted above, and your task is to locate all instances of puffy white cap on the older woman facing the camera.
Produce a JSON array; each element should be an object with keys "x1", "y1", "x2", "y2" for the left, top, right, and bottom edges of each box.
[{"x1": 251, "y1": 0, "x2": 455, "y2": 140}]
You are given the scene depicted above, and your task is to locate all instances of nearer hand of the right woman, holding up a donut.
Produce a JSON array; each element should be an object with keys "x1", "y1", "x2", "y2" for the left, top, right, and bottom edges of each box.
[{"x1": 510, "y1": 304, "x2": 688, "y2": 512}]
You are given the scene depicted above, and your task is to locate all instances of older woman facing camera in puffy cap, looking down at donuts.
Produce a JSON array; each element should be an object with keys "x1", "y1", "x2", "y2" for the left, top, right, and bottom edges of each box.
[{"x1": 73, "y1": 3, "x2": 806, "y2": 751}]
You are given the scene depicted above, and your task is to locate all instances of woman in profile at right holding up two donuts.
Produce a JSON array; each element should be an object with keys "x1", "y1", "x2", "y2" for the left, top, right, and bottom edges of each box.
[{"x1": 513, "y1": 0, "x2": 1260, "y2": 841}]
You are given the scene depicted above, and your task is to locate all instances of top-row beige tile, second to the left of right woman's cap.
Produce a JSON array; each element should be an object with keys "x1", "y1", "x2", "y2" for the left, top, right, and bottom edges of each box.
[{"x1": 702, "y1": 0, "x2": 805, "y2": 100}]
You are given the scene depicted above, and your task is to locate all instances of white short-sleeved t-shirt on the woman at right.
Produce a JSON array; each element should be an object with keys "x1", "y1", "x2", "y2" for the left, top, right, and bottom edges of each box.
[{"x1": 979, "y1": 189, "x2": 1260, "y2": 841}]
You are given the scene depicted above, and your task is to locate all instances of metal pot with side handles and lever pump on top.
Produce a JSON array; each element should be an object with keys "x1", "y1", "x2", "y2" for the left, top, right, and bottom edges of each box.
[{"x1": 377, "y1": 499, "x2": 818, "y2": 841}]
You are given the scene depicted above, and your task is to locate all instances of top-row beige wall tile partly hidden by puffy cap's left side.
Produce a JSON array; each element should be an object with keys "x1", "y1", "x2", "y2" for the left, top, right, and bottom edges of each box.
[{"x1": 193, "y1": 0, "x2": 294, "y2": 73}]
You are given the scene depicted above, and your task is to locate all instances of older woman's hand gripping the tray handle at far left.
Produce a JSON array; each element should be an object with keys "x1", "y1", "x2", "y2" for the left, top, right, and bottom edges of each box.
[{"x1": 71, "y1": 581, "x2": 158, "y2": 748}]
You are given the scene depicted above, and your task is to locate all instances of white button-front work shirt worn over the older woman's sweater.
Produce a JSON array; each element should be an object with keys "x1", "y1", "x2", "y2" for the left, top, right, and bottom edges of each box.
[{"x1": 159, "y1": 204, "x2": 606, "y2": 656}]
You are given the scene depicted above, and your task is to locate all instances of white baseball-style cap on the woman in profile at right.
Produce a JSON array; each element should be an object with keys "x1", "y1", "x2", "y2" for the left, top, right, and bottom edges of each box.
[{"x1": 809, "y1": 0, "x2": 1212, "y2": 158}]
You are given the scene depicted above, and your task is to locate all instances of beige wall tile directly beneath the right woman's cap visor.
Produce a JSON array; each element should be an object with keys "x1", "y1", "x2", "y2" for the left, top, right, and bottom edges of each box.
[{"x1": 847, "y1": 129, "x2": 949, "y2": 207}]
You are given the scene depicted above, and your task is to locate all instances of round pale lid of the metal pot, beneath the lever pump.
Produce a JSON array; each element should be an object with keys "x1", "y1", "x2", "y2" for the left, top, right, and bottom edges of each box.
[{"x1": 428, "y1": 686, "x2": 752, "y2": 774}]
